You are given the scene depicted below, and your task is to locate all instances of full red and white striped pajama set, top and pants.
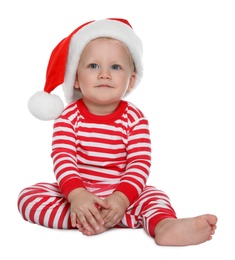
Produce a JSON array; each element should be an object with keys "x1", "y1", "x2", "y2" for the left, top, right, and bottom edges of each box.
[{"x1": 18, "y1": 99, "x2": 176, "y2": 236}]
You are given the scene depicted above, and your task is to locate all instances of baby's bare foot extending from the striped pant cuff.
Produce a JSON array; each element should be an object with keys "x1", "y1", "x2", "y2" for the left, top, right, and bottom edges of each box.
[{"x1": 154, "y1": 214, "x2": 217, "y2": 246}]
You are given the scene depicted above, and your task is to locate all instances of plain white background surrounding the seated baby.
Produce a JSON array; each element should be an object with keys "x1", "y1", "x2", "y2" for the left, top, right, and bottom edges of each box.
[{"x1": 0, "y1": 0, "x2": 235, "y2": 260}]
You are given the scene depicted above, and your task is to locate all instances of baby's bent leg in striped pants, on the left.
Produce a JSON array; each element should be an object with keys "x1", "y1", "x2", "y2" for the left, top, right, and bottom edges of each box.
[{"x1": 18, "y1": 183, "x2": 72, "y2": 229}]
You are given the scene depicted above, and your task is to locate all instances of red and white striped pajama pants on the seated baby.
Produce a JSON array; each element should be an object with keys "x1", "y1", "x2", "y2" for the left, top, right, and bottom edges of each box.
[{"x1": 18, "y1": 183, "x2": 176, "y2": 237}]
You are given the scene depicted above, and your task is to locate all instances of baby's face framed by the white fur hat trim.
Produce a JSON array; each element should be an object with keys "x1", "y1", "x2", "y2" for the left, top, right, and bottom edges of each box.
[{"x1": 75, "y1": 38, "x2": 136, "y2": 114}]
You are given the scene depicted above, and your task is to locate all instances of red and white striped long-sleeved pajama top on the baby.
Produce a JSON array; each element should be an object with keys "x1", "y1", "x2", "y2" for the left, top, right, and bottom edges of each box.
[{"x1": 51, "y1": 99, "x2": 151, "y2": 203}]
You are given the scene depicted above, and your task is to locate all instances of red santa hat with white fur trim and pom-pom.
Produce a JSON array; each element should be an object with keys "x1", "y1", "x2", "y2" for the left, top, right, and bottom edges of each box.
[{"x1": 28, "y1": 18, "x2": 143, "y2": 120}]
